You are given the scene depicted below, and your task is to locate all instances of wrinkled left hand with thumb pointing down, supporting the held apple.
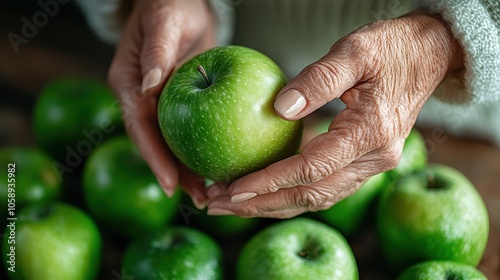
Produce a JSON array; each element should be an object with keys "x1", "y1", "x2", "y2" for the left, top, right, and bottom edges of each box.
[{"x1": 109, "y1": 0, "x2": 215, "y2": 207}]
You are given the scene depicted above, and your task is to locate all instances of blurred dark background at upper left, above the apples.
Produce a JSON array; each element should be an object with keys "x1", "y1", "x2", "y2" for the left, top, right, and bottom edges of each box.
[{"x1": 0, "y1": 0, "x2": 114, "y2": 147}]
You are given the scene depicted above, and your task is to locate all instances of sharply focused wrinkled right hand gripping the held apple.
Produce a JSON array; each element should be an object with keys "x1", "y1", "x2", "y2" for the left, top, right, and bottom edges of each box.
[{"x1": 207, "y1": 13, "x2": 463, "y2": 218}]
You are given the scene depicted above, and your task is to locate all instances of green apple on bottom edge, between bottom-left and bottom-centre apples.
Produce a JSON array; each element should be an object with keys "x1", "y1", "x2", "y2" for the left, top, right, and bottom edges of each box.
[{"x1": 122, "y1": 227, "x2": 222, "y2": 280}]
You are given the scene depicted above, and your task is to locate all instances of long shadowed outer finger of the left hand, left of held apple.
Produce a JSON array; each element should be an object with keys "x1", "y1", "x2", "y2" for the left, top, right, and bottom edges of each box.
[{"x1": 108, "y1": 20, "x2": 178, "y2": 197}]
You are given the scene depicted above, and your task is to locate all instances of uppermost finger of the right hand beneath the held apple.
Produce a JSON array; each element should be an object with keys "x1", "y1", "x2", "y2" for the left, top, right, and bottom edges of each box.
[{"x1": 225, "y1": 111, "x2": 369, "y2": 202}]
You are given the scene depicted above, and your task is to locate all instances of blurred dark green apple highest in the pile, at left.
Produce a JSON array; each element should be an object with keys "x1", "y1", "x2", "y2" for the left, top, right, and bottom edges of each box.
[{"x1": 33, "y1": 78, "x2": 123, "y2": 162}]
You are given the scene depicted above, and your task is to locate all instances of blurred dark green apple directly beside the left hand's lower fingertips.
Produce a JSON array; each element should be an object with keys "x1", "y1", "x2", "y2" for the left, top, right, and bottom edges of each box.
[{"x1": 83, "y1": 136, "x2": 181, "y2": 238}]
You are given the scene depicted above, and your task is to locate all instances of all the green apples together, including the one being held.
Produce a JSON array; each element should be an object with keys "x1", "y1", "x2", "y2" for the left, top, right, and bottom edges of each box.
[{"x1": 0, "y1": 46, "x2": 489, "y2": 280}]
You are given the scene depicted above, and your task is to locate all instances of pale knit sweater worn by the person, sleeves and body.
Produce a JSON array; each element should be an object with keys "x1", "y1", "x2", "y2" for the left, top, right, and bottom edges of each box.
[{"x1": 77, "y1": 0, "x2": 500, "y2": 145}]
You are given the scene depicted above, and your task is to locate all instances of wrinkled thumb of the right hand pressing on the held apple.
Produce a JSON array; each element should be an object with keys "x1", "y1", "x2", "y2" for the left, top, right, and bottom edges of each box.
[{"x1": 274, "y1": 45, "x2": 362, "y2": 120}]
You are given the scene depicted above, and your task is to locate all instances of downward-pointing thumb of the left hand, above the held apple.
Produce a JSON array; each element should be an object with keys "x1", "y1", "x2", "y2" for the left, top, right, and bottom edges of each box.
[{"x1": 140, "y1": 5, "x2": 182, "y2": 95}]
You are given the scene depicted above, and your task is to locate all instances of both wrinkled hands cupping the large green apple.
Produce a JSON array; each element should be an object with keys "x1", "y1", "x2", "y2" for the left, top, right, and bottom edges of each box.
[{"x1": 109, "y1": 0, "x2": 463, "y2": 218}]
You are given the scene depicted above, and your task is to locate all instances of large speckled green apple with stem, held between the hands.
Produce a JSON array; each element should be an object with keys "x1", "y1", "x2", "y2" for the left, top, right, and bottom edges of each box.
[{"x1": 158, "y1": 46, "x2": 302, "y2": 182}]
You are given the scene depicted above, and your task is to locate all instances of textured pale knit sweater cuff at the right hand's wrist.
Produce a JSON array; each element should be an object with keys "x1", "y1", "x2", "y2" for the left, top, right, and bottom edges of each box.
[{"x1": 422, "y1": 0, "x2": 500, "y2": 104}]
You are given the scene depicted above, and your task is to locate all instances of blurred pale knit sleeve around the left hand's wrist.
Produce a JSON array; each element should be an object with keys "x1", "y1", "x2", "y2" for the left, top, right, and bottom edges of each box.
[{"x1": 75, "y1": 0, "x2": 238, "y2": 45}]
